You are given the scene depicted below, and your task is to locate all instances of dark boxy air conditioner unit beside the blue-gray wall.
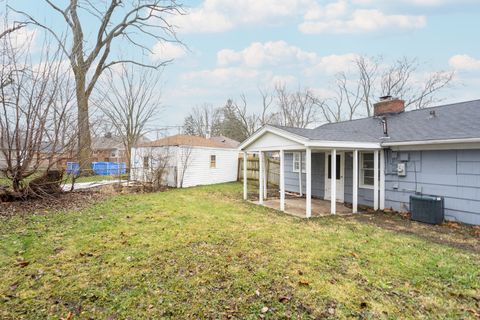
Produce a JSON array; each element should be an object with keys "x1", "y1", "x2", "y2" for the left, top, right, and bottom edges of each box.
[{"x1": 410, "y1": 195, "x2": 445, "y2": 224}]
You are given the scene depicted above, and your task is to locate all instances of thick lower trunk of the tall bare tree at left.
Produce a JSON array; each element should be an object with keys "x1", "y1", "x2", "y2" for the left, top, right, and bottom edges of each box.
[{"x1": 76, "y1": 75, "x2": 92, "y2": 173}]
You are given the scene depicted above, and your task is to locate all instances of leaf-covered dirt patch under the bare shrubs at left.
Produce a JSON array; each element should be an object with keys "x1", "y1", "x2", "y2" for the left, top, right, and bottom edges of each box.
[{"x1": 0, "y1": 189, "x2": 112, "y2": 217}]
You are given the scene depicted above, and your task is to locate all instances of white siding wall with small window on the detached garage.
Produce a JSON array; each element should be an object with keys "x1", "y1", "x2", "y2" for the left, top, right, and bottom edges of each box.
[{"x1": 179, "y1": 147, "x2": 238, "y2": 188}]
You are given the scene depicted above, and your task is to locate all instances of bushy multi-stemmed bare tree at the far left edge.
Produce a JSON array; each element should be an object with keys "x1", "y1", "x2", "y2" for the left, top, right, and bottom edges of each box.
[{"x1": 0, "y1": 33, "x2": 76, "y2": 193}]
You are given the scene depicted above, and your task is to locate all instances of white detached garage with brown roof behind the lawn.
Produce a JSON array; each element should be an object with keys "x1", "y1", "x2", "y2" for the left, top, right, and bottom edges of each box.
[{"x1": 131, "y1": 135, "x2": 239, "y2": 188}]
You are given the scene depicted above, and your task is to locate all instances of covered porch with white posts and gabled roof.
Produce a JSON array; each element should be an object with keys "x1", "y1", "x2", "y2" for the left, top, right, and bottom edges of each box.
[{"x1": 241, "y1": 127, "x2": 385, "y2": 218}]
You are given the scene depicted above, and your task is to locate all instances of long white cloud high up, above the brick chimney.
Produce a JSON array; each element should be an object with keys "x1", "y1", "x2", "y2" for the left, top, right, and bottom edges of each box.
[{"x1": 299, "y1": 0, "x2": 427, "y2": 34}]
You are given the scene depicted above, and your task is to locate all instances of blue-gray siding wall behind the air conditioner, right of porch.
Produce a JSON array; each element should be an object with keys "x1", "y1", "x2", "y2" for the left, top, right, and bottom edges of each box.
[{"x1": 385, "y1": 150, "x2": 480, "y2": 224}]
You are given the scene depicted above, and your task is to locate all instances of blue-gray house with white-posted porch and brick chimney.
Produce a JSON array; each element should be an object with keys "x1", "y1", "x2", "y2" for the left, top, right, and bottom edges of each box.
[{"x1": 239, "y1": 97, "x2": 480, "y2": 224}]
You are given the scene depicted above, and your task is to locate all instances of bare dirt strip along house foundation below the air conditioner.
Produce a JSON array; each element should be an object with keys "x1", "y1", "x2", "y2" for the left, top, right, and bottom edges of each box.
[{"x1": 345, "y1": 212, "x2": 480, "y2": 253}]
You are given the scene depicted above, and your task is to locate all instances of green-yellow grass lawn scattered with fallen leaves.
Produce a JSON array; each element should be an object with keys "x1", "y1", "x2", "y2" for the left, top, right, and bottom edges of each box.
[{"x1": 0, "y1": 183, "x2": 480, "y2": 319}]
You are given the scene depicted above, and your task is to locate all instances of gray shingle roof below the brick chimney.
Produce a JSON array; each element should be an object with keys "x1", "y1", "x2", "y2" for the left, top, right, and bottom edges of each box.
[{"x1": 272, "y1": 100, "x2": 480, "y2": 142}]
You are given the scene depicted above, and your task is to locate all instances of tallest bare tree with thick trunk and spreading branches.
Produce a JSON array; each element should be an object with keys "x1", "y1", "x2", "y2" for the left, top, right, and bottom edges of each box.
[{"x1": 11, "y1": 0, "x2": 184, "y2": 169}]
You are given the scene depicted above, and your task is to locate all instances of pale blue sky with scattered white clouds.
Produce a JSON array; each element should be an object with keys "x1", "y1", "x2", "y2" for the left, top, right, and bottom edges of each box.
[{"x1": 10, "y1": 0, "x2": 480, "y2": 127}]
